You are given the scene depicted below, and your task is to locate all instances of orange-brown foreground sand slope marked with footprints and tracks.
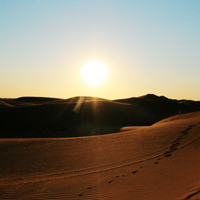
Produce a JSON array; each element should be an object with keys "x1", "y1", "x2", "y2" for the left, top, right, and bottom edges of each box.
[{"x1": 0, "y1": 112, "x2": 200, "y2": 200}]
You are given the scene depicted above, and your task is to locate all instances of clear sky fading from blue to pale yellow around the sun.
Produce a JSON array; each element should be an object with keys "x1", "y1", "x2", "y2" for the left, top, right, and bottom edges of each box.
[{"x1": 0, "y1": 0, "x2": 200, "y2": 100}]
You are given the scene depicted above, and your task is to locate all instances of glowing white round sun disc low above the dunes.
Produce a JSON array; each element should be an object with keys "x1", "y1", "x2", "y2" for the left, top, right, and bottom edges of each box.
[{"x1": 81, "y1": 60, "x2": 108, "y2": 87}]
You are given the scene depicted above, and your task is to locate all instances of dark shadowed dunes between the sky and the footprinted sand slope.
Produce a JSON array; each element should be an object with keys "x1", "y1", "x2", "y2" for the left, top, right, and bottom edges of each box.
[{"x1": 0, "y1": 94, "x2": 200, "y2": 138}]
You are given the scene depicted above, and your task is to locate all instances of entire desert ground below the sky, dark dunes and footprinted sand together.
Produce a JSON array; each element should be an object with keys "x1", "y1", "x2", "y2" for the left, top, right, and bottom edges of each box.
[{"x1": 0, "y1": 94, "x2": 200, "y2": 200}]
